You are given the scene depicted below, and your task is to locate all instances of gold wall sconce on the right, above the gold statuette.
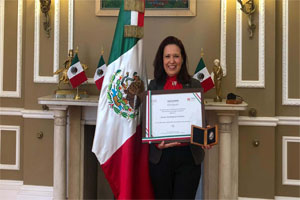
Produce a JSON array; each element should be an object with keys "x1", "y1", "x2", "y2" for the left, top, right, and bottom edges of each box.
[{"x1": 237, "y1": 0, "x2": 256, "y2": 39}]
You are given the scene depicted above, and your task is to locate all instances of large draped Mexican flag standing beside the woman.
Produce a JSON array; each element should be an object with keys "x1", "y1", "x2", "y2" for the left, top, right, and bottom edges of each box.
[{"x1": 92, "y1": 0, "x2": 153, "y2": 199}]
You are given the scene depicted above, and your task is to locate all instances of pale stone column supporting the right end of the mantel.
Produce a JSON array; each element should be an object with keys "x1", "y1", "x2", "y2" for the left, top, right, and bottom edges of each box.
[{"x1": 217, "y1": 112, "x2": 235, "y2": 199}]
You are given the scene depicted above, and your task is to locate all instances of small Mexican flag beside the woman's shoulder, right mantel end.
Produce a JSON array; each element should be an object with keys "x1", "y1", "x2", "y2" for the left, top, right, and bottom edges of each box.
[{"x1": 193, "y1": 57, "x2": 215, "y2": 92}]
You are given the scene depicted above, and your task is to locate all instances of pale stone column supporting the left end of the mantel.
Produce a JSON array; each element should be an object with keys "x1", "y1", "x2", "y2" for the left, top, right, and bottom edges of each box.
[{"x1": 49, "y1": 106, "x2": 67, "y2": 200}]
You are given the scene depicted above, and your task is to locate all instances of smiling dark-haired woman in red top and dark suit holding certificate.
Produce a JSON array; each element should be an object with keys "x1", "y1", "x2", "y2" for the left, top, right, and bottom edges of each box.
[{"x1": 148, "y1": 36, "x2": 210, "y2": 199}]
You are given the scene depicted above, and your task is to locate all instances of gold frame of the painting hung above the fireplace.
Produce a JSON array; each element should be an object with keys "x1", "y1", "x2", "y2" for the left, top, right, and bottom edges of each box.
[{"x1": 95, "y1": 0, "x2": 196, "y2": 17}]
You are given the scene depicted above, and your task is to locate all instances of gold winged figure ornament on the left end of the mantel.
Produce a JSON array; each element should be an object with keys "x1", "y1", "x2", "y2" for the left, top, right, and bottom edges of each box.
[{"x1": 54, "y1": 48, "x2": 88, "y2": 100}]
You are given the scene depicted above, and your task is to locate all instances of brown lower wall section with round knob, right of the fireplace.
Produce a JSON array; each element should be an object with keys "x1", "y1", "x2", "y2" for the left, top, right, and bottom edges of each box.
[{"x1": 239, "y1": 126, "x2": 275, "y2": 199}]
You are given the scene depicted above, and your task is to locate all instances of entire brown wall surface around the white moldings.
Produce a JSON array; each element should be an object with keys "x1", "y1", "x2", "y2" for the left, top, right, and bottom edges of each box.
[{"x1": 0, "y1": 0, "x2": 300, "y2": 198}]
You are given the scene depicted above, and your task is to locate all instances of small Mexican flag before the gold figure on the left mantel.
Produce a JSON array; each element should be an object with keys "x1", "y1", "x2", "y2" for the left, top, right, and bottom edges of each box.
[{"x1": 67, "y1": 53, "x2": 87, "y2": 88}]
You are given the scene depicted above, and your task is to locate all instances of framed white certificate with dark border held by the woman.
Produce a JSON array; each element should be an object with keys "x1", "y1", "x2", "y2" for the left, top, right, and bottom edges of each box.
[{"x1": 142, "y1": 88, "x2": 205, "y2": 143}]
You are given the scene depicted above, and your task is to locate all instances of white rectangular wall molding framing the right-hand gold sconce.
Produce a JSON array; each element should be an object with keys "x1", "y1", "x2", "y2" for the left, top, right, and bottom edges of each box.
[{"x1": 236, "y1": 0, "x2": 265, "y2": 88}]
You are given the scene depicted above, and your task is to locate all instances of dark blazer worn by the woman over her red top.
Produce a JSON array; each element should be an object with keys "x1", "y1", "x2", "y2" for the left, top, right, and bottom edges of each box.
[{"x1": 148, "y1": 78, "x2": 204, "y2": 165}]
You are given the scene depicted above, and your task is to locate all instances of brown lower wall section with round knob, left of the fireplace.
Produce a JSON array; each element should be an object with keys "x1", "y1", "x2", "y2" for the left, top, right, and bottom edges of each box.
[{"x1": 23, "y1": 119, "x2": 53, "y2": 186}]
